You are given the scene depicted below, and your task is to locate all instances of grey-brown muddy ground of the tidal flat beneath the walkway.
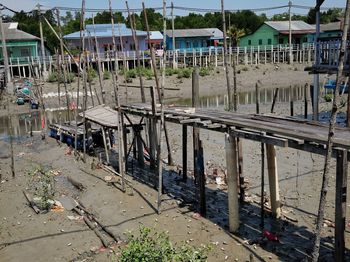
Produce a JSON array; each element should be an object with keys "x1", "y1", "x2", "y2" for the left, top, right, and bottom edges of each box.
[{"x1": 0, "y1": 62, "x2": 350, "y2": 261}]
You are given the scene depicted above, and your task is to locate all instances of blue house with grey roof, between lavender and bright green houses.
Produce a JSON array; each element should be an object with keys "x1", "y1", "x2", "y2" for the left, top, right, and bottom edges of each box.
[{"x1": 166, "y1": 28, "x2": 224, "y2": 51}]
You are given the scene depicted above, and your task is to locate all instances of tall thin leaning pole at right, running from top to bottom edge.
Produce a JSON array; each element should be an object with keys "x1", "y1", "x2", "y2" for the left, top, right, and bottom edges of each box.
[{"x1": 312, "y1": 0, "x2": 350, "y2": 262}]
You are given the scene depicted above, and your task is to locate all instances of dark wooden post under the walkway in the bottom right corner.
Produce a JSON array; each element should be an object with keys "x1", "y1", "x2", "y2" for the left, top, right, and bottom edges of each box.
[{"x1": 335, "y1": 149, "x2": 348, "y2": 261}]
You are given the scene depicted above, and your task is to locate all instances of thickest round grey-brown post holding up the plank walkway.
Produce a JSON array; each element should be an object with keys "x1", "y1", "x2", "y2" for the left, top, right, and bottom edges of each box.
[{"x1": 225, "y1": 134, "x2": 239, "y2": 233}]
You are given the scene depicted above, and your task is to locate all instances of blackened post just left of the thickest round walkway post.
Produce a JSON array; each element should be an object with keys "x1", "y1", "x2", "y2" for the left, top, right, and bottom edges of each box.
[{"x1": 196, "y1": 138, "x2": 207, "y2": 217}]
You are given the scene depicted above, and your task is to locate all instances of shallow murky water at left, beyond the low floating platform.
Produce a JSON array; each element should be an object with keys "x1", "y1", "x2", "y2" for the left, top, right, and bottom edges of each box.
[{"x1": 0, "y1": 110, "x2": 73, "y2": 139}]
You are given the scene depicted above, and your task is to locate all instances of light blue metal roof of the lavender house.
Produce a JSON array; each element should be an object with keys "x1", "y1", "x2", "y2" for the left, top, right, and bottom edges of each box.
[{"x1": 63, "y1": 24, "x2": 147, "y2": 39}]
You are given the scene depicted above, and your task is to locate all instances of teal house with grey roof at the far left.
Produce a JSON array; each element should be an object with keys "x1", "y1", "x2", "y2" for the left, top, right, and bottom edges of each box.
[{"x1": 0, "y1": 23, "x2": 40, "y2": 64}]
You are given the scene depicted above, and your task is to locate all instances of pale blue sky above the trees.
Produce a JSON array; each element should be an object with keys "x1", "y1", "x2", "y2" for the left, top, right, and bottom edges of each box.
[{"x1": 0, "y1": 0, "x2": 346, "y2": 16}]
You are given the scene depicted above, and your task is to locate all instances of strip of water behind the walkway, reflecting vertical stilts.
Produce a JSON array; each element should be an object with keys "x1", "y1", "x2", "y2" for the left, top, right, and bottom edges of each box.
[{"x1": 167, "y1": 86, "x2": 304, "y2": 108}]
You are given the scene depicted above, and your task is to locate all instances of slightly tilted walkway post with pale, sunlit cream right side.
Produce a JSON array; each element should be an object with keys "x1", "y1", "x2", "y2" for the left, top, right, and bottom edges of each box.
[{"x1": 266, "y1": 144, "x2": 281, "y2": 218}]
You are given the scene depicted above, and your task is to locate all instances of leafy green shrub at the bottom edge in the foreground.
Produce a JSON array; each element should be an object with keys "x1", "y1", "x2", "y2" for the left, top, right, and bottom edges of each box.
[{"x1": 119, "y1": 226, "x2": 210, "y2": 262}]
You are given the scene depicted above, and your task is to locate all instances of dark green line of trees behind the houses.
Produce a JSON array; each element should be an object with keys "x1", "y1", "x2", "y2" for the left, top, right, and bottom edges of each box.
[{"x1": 6, "y1": 8, "x2": 343, "y2": 52}]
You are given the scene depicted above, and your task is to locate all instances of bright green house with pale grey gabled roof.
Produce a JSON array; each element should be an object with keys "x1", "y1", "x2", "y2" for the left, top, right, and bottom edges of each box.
[{"x1": 239, "y1": 21, "x2": 315, "y2": 47}]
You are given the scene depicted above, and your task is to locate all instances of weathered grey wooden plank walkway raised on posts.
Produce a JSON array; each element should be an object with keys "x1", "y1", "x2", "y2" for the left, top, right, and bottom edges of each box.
[{"x1": 122, "y1": 104, "x2": 350, "y2": 154}]
